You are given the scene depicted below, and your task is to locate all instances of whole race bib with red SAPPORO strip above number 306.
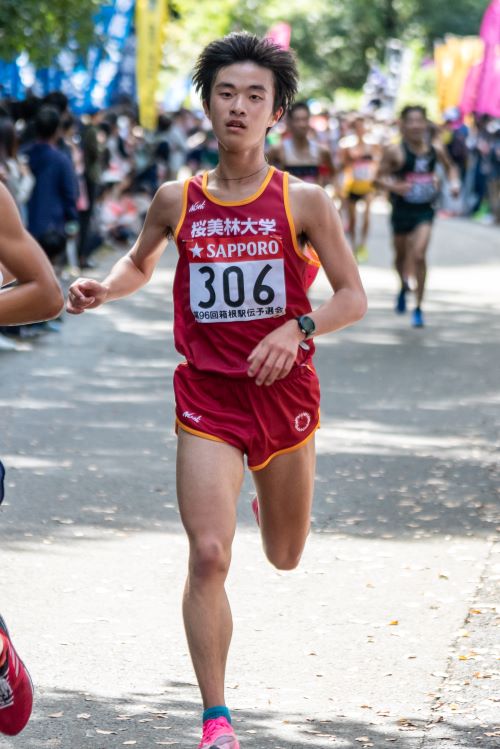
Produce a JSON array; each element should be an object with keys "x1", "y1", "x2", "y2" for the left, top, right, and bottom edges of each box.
[{"x1": 186, "y1": 235, "x2": 286, "y2": 323}]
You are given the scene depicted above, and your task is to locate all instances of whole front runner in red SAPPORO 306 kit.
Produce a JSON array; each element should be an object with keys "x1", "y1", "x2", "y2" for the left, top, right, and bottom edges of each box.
[{"x1": 67, "y1": 33, "x2": 366, "y2": 749}]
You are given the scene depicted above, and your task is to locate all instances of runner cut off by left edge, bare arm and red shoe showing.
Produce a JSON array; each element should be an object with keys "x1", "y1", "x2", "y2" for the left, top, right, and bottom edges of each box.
[{"x1": 0, "y1": 184, "x2": 64, "y2": 736}]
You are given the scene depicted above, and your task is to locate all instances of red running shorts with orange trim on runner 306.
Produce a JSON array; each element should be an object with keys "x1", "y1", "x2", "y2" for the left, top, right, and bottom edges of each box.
[{"x1": 174, "y1": 362, "x2": 319, "y2": 471}]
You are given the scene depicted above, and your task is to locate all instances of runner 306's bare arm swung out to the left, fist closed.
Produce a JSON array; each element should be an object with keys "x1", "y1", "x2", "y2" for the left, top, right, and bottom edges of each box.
[{"x1": 66, "y1": 182, "x2": 183, "y2": 315}]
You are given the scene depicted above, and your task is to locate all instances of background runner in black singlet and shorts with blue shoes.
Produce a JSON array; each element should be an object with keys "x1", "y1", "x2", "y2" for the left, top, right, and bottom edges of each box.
[{"x1": 376, "y1": 105, "x2": 460, "y2": 328}]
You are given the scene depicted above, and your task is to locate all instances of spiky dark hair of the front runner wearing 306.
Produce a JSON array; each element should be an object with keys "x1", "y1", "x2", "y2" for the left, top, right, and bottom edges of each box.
[{"x1": 193, "y1": 31, "x2": 298, "y2": 117}]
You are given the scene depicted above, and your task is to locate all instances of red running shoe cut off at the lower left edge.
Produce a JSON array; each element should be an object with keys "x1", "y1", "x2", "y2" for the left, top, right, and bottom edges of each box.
[{"x1": 0, "y1": 616, "x2": 33, "y2": 736}]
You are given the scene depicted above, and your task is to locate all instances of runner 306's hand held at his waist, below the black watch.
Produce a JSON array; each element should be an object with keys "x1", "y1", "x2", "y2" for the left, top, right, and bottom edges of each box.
[{"x1": 247, "y1": 320, "x2": 304, "y2": 385}]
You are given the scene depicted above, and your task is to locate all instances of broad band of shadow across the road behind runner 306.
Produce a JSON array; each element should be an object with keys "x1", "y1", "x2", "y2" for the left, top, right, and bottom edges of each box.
[{"x1": 0, "y1": 241, "x2": 500, "y2": 548}]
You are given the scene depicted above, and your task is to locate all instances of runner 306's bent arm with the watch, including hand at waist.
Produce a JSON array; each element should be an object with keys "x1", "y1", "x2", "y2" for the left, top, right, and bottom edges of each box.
[{"x1": 248, "y1": 180, "x2": 366, "y2": 385}]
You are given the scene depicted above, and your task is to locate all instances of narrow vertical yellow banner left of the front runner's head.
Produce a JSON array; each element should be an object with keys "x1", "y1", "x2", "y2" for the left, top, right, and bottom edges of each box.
[{"x1": 135, "y1": 0, "x2": 167, "y2": 130}]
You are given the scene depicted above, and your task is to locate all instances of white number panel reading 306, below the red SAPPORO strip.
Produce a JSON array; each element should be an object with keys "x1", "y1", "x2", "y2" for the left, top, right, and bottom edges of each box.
[{"x1": 190, "y1": 259, "x2": 286, "y2": 322}]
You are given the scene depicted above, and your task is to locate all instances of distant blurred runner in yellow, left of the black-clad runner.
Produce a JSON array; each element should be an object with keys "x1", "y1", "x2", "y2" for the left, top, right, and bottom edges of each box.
[{"x1": 340, "y1": 115, "x2": 381, "y2": 262}]
